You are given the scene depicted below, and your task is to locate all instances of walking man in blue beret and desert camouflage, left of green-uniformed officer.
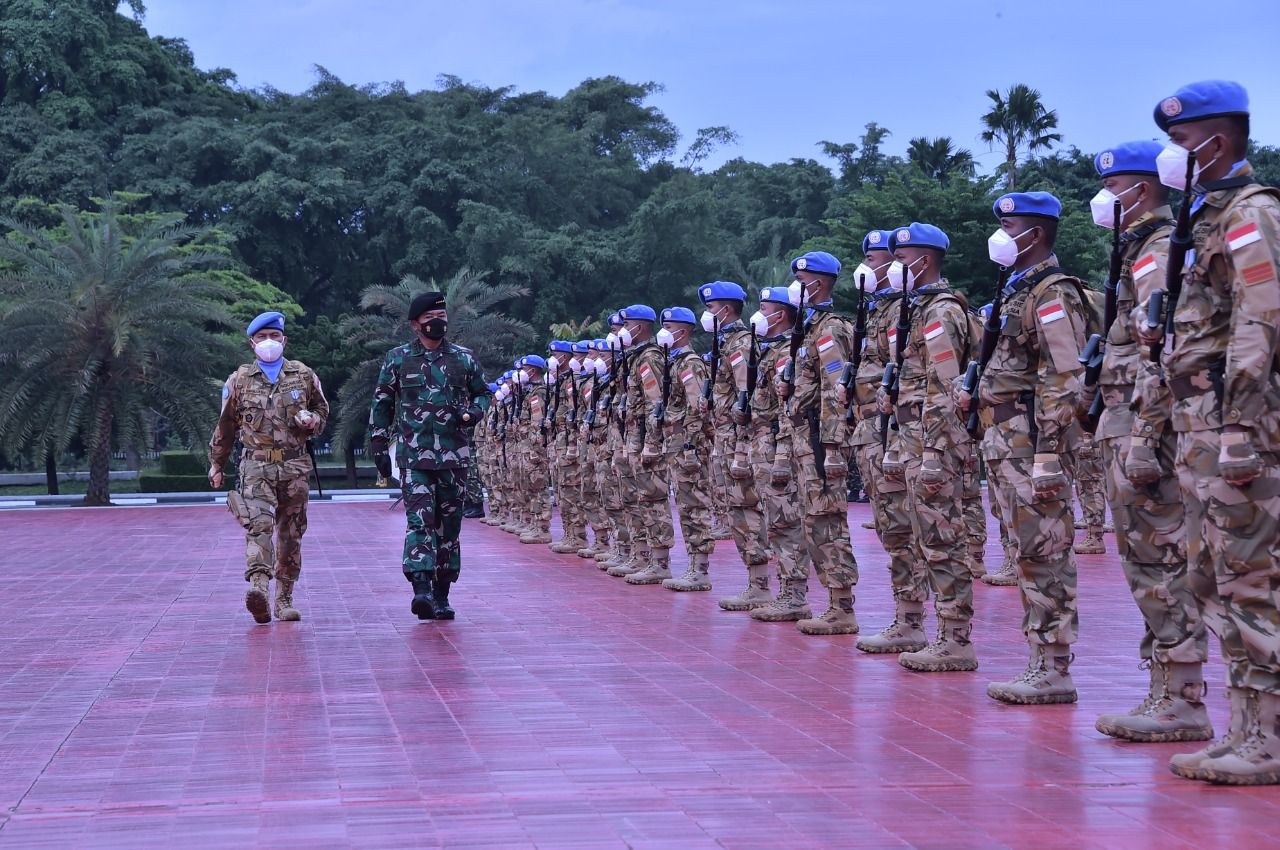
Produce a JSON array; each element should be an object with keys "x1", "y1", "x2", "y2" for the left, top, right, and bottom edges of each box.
[{"x1": 209, "y1": 311, "x2": 329, "y2": 623}]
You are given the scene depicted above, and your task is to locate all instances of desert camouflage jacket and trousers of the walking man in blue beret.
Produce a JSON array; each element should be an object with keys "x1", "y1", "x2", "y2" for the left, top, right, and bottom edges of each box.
[{"x1": 209, "y1": 360, "x2": 329, "y2": 581}]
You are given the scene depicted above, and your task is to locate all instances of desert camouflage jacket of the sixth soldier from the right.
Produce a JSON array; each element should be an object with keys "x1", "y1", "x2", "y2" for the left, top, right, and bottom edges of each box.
[{"x1": 791, "y1": 307, "x2": 854, "y2": 448}]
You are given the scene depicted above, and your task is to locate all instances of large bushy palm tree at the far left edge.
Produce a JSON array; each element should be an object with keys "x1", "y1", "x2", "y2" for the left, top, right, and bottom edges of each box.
[{"x1": 0, "y1": 204, "x2": 234, "y2": 504}]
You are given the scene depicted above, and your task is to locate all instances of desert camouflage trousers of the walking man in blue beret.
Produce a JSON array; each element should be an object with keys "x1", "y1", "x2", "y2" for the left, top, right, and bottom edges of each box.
[{"x1": 227, "y1": 457, "x2": 311, "y2": 581}]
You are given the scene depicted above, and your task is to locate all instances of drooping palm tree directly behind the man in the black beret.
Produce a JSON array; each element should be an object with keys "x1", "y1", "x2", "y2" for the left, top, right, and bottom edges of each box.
[{"x1": 334, "y1": 269, "x2": 535, "y2": 458}]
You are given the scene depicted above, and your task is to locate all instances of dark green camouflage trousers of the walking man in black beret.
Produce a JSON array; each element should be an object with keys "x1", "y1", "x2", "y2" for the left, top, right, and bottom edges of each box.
[{"x1": 403, "y1": 469, "x2": 466, "y2": 581}]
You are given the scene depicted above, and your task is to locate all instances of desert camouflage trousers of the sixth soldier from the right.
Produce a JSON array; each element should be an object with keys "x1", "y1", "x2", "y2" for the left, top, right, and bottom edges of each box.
[{"x1": 791, "y1": 435, "x2": 858, "y2": 589}]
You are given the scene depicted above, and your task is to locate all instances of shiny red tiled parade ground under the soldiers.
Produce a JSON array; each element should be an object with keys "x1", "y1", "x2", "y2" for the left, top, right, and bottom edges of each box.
[{"x1": 0, "y1": 503, "x2": 1280, "y2": 850}]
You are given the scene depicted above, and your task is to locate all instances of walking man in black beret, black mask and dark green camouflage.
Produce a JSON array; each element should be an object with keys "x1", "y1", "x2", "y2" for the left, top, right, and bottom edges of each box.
[{"x1": 369, "y1": 292, "x2": 489, "y2": 620}]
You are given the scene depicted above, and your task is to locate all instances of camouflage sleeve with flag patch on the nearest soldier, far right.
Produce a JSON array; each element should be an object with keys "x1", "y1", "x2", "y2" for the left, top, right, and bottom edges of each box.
[{"x1": 1222, "y1": 196, "x2": 1280, "y2": 428}]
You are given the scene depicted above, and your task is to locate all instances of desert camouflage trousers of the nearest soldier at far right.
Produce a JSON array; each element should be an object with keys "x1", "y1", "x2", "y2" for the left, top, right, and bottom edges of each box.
[{"x1": 1178, "y1": 431, "x2": 1280, "y2": 694}]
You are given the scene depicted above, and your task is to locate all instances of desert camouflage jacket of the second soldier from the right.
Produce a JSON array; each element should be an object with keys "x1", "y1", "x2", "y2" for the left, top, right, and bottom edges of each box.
[{"x1": 1094, "y1": 206, "x2": 1172, "y2": 440}]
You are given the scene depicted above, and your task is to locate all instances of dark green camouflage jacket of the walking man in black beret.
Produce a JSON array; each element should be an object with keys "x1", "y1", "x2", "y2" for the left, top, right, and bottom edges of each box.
[{"x1": 369, "y1": 339, "x2": 489, "y2": 470}]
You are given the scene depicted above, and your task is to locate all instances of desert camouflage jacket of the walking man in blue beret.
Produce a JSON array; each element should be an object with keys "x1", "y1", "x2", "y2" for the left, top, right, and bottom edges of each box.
[{"x1": 209, "y1": 360, "x2": 329, "y2": 469}]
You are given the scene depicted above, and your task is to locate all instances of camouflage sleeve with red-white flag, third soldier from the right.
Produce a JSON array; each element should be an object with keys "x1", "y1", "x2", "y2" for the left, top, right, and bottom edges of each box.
[{"x1": 1029, "y1": 282, "x2": 1085, "y2": 453}]
